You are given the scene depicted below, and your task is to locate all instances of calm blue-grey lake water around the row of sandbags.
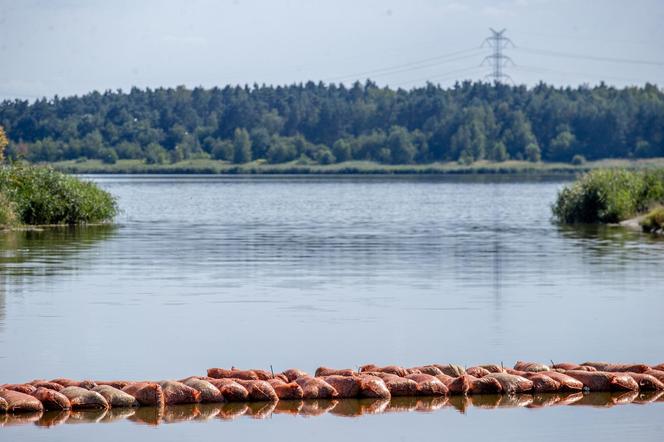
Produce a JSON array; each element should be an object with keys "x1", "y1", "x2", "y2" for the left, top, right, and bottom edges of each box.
[{"x1": 0, "y1": 176, "x2": 664, "y2": 440}]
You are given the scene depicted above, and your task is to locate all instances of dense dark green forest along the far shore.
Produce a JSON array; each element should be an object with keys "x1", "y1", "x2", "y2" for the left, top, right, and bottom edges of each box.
[{"x1": 0, "y1": 81, "x2": 664, "y2": 164}]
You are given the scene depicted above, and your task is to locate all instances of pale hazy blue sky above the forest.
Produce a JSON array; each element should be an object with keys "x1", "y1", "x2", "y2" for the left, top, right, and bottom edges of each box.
[{"x1": 0, "y1": 0, "x2": 664, "y2": 100}]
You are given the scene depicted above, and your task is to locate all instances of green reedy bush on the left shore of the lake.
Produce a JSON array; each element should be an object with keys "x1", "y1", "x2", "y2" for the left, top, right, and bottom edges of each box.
[{"x1": 0, "y1": 163, "x2": 117, "y2": 224}]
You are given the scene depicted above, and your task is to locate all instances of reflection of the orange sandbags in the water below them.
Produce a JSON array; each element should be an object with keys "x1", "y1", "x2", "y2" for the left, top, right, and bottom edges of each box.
[{"x1": 0, "y1": 391, "x2": 664, "y2": 427}]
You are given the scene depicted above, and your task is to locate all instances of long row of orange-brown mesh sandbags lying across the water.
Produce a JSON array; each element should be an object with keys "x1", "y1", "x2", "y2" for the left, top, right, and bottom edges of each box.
[{"x1": 0, "y1": 361, "x2": 664, "y2": 413}]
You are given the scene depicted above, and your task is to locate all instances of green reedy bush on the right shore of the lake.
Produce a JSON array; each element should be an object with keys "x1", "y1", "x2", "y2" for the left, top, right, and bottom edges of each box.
[{"x1": 552, "y1": 169, "x2": 664, "y2": 224}]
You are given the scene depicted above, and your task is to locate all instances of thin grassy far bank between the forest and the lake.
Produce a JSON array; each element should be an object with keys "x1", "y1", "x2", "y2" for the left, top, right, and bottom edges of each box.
[{"x1": 51, "y1": 158, "x2": 664, "y2": 174}]
